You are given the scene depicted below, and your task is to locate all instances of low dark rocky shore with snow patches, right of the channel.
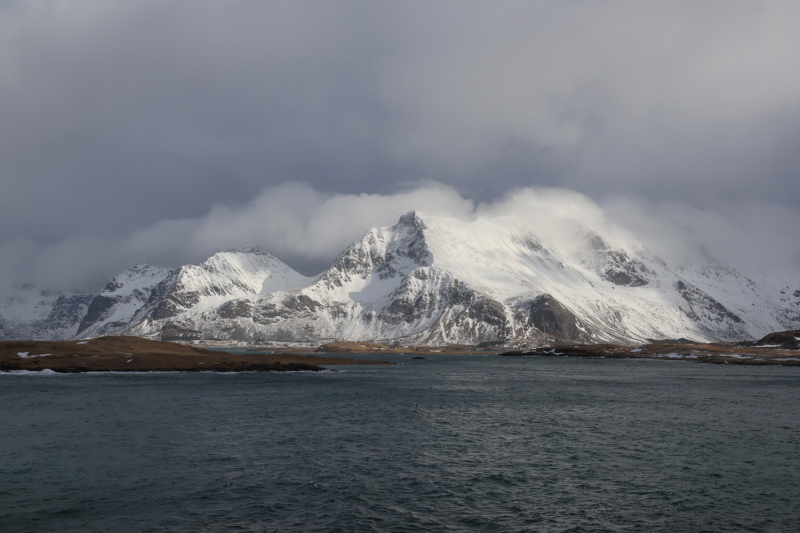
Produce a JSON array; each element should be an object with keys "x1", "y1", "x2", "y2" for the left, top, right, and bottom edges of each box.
[{"x1": 499, "y1": 330, "x2": 800, "y2": 366}]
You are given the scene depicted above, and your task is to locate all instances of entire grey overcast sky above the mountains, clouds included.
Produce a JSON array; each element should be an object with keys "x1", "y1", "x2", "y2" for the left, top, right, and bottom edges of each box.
[{"x1": 0, "y1": 0, "x2": 800, "y2": 290}]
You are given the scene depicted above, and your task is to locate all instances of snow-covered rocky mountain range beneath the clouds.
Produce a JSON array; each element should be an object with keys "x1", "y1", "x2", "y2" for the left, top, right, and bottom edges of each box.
[{"x1": 0, "y1": 212, "x2": 800, "y2": 345}]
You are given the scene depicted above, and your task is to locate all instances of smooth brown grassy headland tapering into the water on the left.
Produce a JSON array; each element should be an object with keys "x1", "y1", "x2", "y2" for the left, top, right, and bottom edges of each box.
[{"x1": 0, "y1": 336, "x2": 393, "y2": 373}]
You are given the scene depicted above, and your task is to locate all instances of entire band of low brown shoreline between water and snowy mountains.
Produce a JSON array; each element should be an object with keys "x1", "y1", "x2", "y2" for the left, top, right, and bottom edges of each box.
[{"x1": 0, "y1": 330, "x2": 800, "y2": 373}]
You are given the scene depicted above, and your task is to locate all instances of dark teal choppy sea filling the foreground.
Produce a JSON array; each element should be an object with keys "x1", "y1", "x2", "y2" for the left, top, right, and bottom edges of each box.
[{"x1": 0, "y1": 356, "x2": 800, "y2": 532}]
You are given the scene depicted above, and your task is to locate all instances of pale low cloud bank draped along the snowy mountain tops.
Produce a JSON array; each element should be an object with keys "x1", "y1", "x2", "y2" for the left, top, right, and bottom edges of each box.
[{"x1": 0, "y1": 183, "x2": 800, "y2": 290}]
